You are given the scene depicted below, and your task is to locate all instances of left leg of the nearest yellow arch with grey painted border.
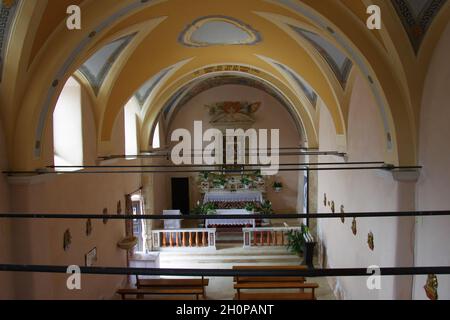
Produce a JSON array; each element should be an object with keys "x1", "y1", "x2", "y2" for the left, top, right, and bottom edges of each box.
[{"x1": 10, "y1": 0, "x2": 164, "y2": 170}]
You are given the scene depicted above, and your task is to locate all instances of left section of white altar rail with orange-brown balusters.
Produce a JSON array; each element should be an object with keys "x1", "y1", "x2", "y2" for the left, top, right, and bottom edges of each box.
[{"x1": 152, "y1": 228, "x2": 216, "y2": 250}]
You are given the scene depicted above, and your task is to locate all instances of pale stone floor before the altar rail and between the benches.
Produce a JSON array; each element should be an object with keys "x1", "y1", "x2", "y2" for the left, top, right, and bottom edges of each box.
[{"x1": 159, "y1": 244, "x2": 335, "y2": 300}]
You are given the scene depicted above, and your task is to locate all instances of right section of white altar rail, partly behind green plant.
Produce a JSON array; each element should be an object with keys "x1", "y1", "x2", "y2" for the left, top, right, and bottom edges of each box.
[{"x1": 242, "y1": 227, "x2": 301, "y2": 248}]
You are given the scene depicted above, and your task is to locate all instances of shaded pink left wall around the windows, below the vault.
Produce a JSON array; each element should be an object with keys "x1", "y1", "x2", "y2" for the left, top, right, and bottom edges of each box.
[{"x1": 6, "y1": 86, "x2": 141, "y2": 299}]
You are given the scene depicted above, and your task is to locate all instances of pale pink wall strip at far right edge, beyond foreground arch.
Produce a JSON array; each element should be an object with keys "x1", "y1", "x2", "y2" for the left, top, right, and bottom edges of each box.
[{"x1": 414, "y1": 24, "x2": 450, "y2": 299}]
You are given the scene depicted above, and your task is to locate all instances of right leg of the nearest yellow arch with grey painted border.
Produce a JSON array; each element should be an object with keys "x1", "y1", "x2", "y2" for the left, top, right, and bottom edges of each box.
[{"x1": 274, "y1": 0, "x2": 417, "y2": 165}]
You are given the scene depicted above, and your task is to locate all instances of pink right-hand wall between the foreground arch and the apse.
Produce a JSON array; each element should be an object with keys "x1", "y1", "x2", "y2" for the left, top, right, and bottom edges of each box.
[{"x1": 318, "y1": 77, "x2": 414, "y2": 299}]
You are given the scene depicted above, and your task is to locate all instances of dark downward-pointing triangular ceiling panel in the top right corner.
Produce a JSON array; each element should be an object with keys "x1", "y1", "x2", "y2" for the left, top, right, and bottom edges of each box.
[{"x1": 391, "y1": 0, "x2": 447, "y2": 54}]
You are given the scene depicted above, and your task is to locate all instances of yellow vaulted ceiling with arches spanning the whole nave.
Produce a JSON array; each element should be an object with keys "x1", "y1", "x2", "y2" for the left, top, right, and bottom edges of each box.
[{"x1": 2, "y1": 0, "x2": 450, "y2": 169}]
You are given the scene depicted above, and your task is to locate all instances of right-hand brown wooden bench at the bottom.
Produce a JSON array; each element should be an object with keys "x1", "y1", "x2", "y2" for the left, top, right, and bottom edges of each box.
[{"x1": 234, "y1": 282, "x2": 319, "y2": 300}]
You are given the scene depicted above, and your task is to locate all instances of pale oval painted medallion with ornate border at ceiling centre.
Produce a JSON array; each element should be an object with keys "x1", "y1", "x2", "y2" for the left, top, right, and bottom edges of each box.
[{"x1": 179, "y1": 16, "x2": 262, "y2": 47}]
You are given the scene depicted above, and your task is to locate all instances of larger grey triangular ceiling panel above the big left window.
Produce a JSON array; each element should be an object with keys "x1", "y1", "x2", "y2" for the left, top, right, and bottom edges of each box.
[{"x1": 79, "y1": 33, "x2": 136, "y2": 95}]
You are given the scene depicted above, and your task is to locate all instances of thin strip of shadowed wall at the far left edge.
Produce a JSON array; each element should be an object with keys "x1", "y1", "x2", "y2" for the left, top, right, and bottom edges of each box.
[{"x1": 0, "y1": 119, "x2": 14, "y2": 299}]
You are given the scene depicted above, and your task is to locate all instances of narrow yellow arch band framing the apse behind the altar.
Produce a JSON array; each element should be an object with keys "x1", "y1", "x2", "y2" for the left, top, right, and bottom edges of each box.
[{"x1": 141, "y1": 64, "x2": 318, "y2": 150}]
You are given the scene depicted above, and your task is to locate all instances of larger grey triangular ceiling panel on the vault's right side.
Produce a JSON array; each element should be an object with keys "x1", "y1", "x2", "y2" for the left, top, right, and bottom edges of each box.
[{"x1": 290, "y1": 26, "x2": 353, "y2": 89}]
